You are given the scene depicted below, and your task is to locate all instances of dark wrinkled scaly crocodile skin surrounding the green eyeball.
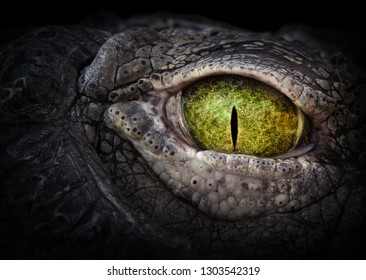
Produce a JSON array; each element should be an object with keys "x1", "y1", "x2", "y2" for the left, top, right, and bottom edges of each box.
[{"x1": 0, "y1": 17, "x2": 366, "y2": 259}]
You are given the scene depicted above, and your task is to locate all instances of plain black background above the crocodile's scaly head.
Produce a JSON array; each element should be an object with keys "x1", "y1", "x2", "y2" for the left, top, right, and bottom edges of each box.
[{"x1": 0, "y1": 0, "x2": 366, "y2": 33}]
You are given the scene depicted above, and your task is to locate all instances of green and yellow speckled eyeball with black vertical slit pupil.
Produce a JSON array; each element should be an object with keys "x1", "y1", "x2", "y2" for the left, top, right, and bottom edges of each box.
[{"x1": 182, "y1": 76, "x2": 303, "y2": 156}]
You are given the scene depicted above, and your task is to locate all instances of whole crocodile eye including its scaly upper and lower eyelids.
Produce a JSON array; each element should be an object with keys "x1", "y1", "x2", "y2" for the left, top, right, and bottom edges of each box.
[{"x1": 100, "y1": 32, "x2": 340, "y2": 221}]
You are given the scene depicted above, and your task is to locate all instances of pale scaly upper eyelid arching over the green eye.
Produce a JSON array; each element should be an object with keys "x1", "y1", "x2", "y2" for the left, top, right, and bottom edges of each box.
[{"x1": 151, "y1": 55, "x2": 339, "y2": 120}]
